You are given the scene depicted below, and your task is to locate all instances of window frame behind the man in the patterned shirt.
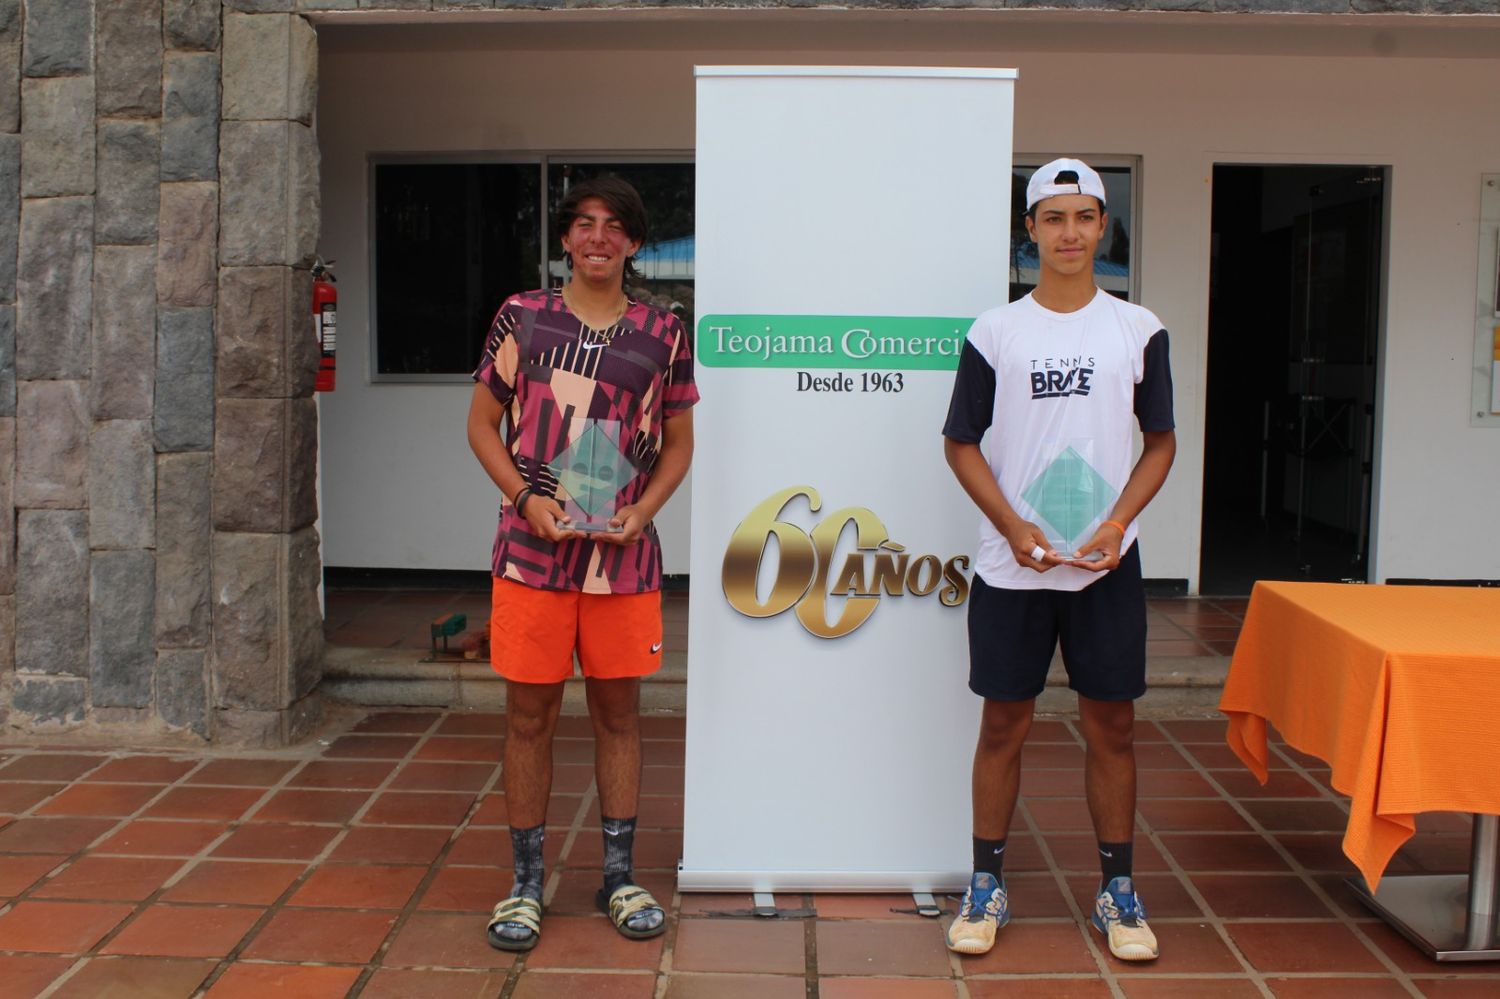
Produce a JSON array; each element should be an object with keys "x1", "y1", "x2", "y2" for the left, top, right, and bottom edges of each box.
[{"x1": 365, "y1": 149, "x2": 696, "y2": 386}]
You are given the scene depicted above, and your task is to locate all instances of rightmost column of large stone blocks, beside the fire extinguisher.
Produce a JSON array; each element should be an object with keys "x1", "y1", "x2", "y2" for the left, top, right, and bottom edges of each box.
[{"x1": 212, "y1": 5, "x2": 323, "y2": 743}]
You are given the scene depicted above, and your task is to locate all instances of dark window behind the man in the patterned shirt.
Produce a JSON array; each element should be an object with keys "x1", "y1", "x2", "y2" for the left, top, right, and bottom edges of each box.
[{"x1": 372, "y1": 158, "x2": 695, "y2": 381}]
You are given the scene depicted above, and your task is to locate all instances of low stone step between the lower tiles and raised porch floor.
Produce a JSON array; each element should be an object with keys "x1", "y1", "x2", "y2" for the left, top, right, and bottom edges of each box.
[{"x1": 320, "y1": 645, "x2": 1229, "y2": 719}]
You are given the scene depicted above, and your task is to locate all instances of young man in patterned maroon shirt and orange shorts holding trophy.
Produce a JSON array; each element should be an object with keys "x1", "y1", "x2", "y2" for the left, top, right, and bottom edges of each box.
[{"x1": 468, "y1": 177, "x2": 698, "y2": 951}]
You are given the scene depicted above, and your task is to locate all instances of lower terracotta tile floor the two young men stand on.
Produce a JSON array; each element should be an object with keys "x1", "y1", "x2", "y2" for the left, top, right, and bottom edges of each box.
[{"x1": 0, "y1": 711, "x2": 1500, "y2": 999}]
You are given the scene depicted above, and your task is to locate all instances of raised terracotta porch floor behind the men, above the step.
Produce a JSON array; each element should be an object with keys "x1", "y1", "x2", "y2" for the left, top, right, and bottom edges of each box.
[{"x1": 323, "y1": 575, "x2": 1248, "y2": 659}]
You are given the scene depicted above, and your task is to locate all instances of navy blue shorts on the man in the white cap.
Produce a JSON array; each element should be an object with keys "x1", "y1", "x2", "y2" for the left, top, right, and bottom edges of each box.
[{"x1": 969, "y1": 545, "x2": 1146, "y2": 701}]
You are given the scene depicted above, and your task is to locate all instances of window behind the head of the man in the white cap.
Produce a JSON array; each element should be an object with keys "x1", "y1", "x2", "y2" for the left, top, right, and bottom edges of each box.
[{"x1": 1011, "y1": 156, "x2": 1139, "y2": 302}]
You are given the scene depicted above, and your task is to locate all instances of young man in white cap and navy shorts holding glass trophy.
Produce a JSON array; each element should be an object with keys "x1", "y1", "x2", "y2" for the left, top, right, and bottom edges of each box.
[{"x1": 944, "y1": 159, "x2": 1176, "y2": 960}]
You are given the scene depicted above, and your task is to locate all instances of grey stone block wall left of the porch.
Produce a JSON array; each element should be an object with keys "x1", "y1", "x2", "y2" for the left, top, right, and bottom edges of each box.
[{"x1": 0, "y1": 0, "x2": 323, "y2": 744}]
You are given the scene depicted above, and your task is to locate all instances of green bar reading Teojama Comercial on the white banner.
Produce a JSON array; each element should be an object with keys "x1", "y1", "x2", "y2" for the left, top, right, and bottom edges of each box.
[{"x1": 696, "y1": 315, "x2": 974, "y2": 371}]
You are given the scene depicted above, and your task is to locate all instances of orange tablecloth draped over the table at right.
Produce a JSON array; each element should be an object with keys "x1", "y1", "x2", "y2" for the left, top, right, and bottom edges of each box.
[{"x1": 1220, "y1": 582, "x2": 1500, "y2": 891}]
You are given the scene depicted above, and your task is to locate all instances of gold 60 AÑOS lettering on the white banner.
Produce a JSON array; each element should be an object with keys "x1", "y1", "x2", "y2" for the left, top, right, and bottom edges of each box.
[{"x1": 723, "y1": 486, "x2": 969, "y2": 639}]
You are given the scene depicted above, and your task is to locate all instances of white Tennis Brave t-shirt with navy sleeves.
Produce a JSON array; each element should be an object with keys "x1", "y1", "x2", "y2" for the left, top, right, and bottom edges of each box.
[{"x1": 944, "y1": 291, "x2": 1173, "y2": 590}]
